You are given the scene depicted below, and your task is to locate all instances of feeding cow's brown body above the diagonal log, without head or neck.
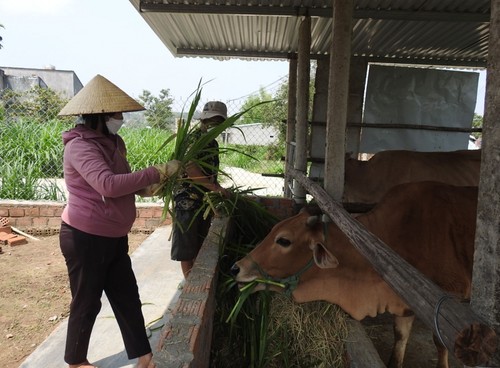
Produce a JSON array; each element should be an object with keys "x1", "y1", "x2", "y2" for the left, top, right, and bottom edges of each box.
[{"x1": 358, "y1": 182, "x2": 477, "y2": 297}]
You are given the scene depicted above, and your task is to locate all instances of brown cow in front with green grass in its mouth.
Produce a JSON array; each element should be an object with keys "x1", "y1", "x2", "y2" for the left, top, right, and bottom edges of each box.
[{"x1": 232, "y1": 182, "x2": 477, "y2": 368}]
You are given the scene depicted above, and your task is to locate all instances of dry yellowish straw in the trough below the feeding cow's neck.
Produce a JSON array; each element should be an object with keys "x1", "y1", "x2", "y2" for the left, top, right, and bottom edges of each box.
[{"x1": 267, "y1": 293, "x2": 347, "y2": 368}]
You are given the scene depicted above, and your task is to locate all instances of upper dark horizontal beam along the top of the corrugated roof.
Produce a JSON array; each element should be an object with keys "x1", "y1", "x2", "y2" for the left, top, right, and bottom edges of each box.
[{"x1": 139, "y1": 0, "x2": 490, "y2": 23}]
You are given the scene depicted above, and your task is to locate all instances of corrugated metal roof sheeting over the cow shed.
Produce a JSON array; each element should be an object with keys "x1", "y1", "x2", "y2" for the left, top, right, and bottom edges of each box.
[{"x1": 130, "y1": 0, "x2": 490, "y2": 67}]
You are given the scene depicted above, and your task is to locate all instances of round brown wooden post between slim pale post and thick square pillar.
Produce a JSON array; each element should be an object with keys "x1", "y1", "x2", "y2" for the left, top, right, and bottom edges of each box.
[{"x1": 293, "y1": 17, "x2": 311, "y2": 204}]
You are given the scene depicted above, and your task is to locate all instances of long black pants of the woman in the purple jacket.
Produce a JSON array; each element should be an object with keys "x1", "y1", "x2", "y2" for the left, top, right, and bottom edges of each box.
[{"x1": 59, "y1": 223, "x2": 151, "y2": 364}]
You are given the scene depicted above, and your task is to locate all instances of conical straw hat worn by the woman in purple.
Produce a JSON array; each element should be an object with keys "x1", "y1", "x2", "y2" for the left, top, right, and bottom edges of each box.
[{"x1": 59, "y1": 74, "x2": 145, "y2": 116}]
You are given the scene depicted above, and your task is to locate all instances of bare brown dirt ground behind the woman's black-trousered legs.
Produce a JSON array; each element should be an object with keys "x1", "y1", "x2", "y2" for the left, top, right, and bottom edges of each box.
[{"x1": 0, "y1": 233, "x2": 148, "y2": 368}]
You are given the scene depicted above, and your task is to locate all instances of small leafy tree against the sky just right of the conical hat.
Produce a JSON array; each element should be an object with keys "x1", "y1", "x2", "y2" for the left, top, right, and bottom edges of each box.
[{"x1": 138, "y1": 89, "x2": 175, "y2": 130}]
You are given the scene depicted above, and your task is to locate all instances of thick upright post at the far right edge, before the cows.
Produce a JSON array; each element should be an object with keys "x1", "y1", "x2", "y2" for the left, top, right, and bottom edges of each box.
[{"x1": 471, "y1": 1, "x2": 500, "y2": 330}]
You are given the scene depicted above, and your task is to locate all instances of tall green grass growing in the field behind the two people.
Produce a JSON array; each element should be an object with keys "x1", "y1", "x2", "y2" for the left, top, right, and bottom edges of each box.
[{"x1": 0, "y1": 119, "x2": 283, "y2": 201}]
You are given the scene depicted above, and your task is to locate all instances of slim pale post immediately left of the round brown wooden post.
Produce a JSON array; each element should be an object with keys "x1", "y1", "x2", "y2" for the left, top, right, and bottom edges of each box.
[{"x1": 284, "y1": 57, "x2": 297, "y2": 198}]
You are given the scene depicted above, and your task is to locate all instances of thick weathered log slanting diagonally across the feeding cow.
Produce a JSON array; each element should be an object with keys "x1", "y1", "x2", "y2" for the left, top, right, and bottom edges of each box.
[{"x1": 292, "y1": 171, "x2": 500, "y2": 366}]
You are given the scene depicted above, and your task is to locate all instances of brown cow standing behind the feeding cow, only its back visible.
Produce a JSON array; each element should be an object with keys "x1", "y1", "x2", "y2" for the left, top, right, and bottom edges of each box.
[{"x1": 343, "y1": 150, "x2": 481, "y2": 204}]
